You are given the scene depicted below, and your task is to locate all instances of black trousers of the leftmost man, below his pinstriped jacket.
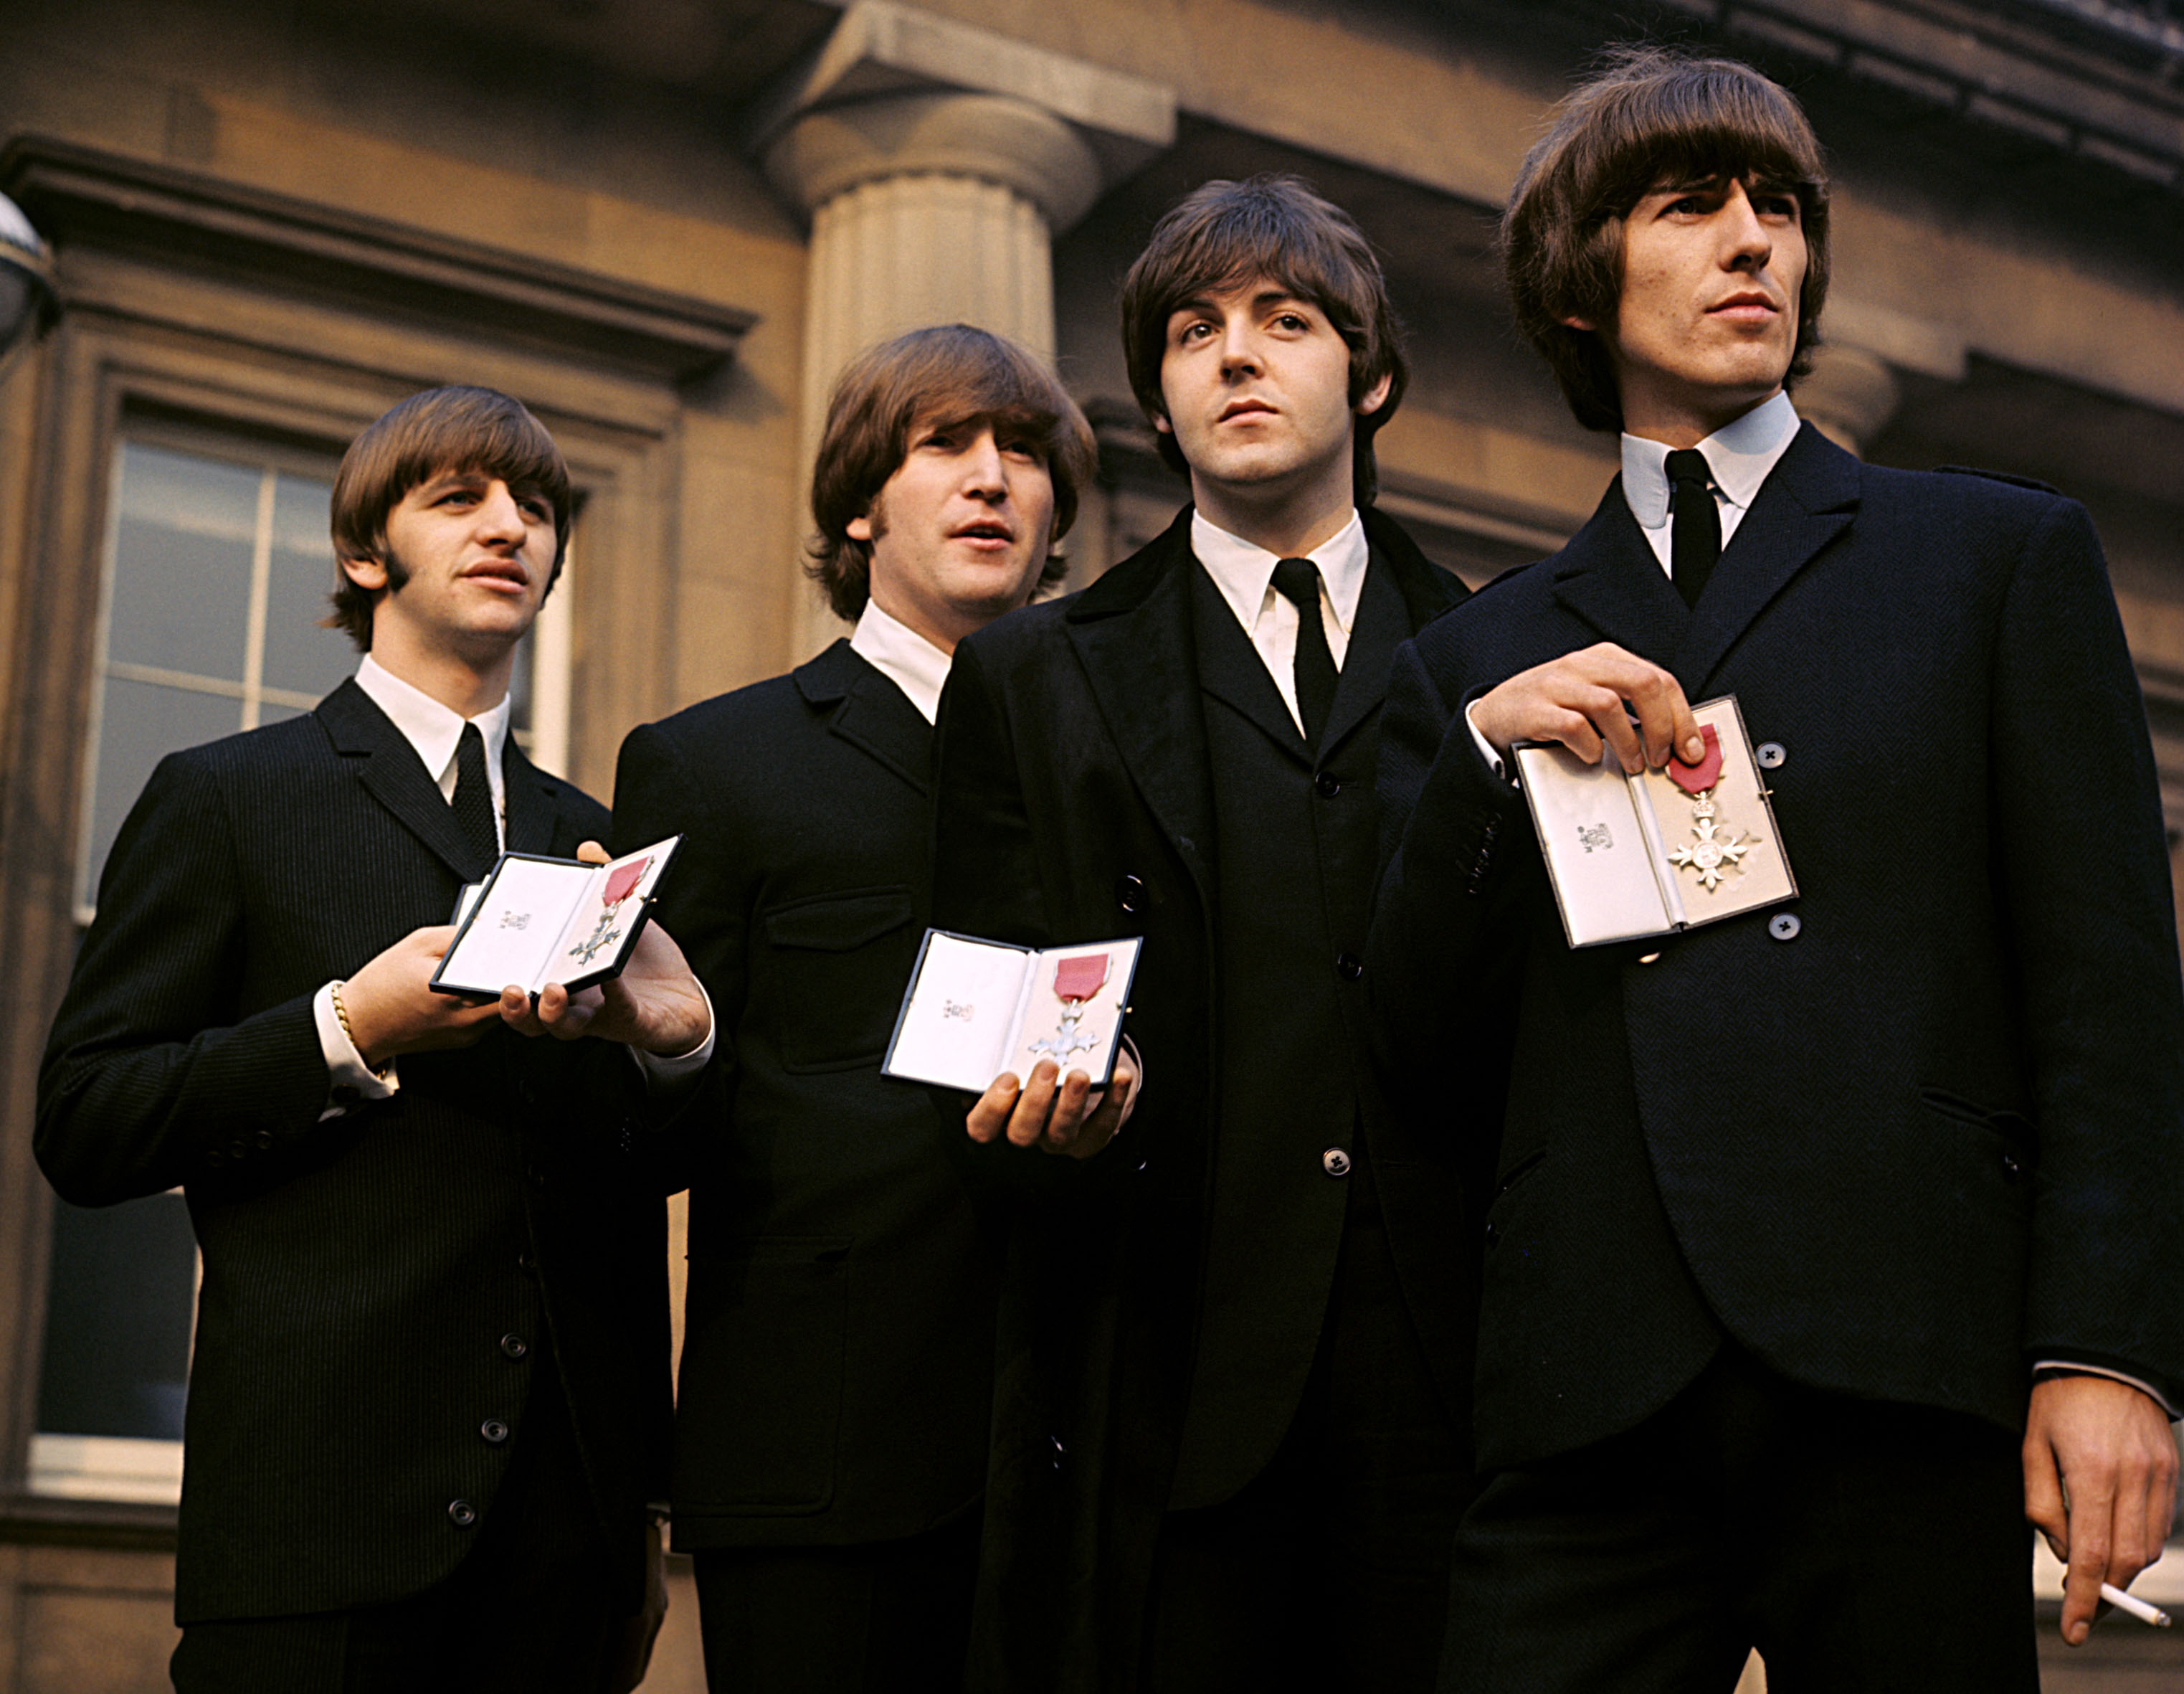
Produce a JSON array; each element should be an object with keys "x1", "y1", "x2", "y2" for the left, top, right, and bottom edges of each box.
[{"x1": 171, "y1": 1355, "x2": 642, "y2": 1694}]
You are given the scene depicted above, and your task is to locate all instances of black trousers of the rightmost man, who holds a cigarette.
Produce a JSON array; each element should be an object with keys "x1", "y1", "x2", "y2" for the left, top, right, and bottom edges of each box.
[{"x1": 1441, "y1": 1346, "x2": 2040, "y2": 1694}]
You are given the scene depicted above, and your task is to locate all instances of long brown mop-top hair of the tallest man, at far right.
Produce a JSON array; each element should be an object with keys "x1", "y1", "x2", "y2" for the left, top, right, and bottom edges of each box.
[{"x1": 1501, "y1": 46, "x2": 1828, "y2": 428}]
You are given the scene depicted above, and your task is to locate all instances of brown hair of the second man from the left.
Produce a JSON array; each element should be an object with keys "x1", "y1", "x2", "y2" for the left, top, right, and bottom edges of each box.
[{"x1": 804, "y1": 323, "x2": 1098, "y2": 621}]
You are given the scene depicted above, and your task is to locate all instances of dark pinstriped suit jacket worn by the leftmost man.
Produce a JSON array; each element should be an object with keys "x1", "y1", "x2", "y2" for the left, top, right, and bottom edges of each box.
[{"x1": 37, "y1": 682, "x2": 668, "y2": 1624}]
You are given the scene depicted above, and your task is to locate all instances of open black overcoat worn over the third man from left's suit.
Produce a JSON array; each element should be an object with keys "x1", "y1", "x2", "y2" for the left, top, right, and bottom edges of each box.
[{"x1": 933, "y1": 511, "x2": 1468, "y2": 1694}]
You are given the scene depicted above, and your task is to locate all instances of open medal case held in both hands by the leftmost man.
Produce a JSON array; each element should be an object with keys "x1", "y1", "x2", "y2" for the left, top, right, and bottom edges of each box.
[{"x1": 432, "y1": 835, "x2": 681, "y2": 999}]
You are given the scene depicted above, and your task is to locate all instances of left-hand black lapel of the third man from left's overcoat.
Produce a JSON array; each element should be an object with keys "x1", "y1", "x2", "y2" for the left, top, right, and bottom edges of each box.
[{"x1": 1063, "y1": 507, "x2": 1222, "y2": 899}]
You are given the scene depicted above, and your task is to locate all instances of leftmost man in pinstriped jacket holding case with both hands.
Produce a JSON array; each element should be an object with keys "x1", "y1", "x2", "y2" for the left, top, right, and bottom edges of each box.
[{"x1": 37, "y1": 387, "x2": 710, "y2": 1694}]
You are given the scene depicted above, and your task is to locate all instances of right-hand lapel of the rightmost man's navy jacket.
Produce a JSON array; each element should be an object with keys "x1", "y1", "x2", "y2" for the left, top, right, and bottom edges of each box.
[{"x1": 1656, "y1": 424, "x2": 1858, "y2": 699}]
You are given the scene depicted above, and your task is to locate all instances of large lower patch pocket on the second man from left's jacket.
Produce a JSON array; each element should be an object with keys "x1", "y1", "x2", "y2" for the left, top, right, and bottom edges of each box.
[{"x1": 675, "y1": 1235, "x2": 852, "y2": 1517}]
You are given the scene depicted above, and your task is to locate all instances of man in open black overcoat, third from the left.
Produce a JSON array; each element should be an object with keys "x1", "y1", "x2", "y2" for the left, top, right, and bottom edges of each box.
[{"x1": 933, "y1": 177, "x2": 1470, "y2": 1694}]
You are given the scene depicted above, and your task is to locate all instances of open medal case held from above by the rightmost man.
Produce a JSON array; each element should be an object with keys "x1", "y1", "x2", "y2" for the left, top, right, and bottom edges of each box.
[{"x1": 1516, "y1": 695, "x2": 1798, "y2": 947}]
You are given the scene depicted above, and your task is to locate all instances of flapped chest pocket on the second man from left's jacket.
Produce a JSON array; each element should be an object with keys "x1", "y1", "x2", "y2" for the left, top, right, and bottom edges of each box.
[{"x1": 754, "y1": 887, "x2": 913, "y2": 1073}]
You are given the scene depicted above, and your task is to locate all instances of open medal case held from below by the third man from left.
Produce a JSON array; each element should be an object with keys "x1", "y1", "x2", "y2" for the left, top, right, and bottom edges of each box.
[{"x1": 880, "y1": 929, "x2": 1140, "y2": 1093}]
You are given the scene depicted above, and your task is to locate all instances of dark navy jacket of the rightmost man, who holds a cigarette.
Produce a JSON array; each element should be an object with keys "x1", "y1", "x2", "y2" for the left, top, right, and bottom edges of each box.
[{"x1": 1374, "y1": 424, "x2": 2184, "y2": 1464}]
